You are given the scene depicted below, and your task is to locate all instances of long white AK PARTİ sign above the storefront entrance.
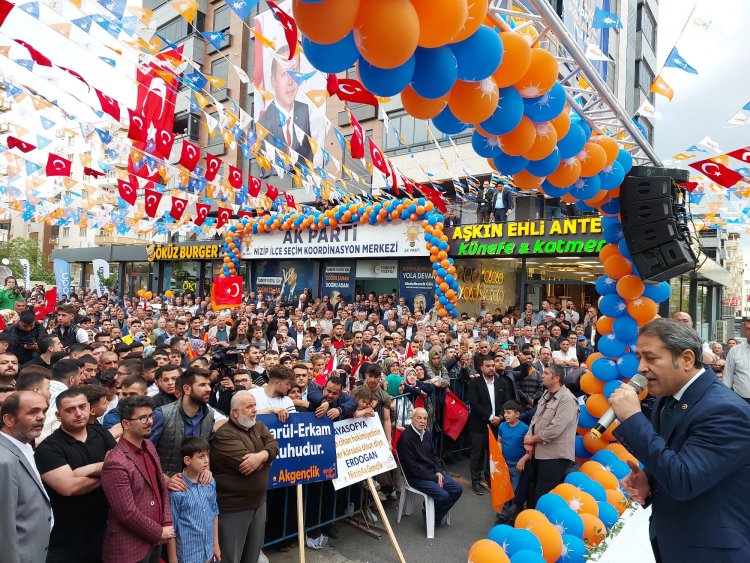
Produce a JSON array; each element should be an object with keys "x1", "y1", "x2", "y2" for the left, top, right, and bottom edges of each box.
[{"x1": 242, "y1": 222, "x2": 429, "y2": 259}]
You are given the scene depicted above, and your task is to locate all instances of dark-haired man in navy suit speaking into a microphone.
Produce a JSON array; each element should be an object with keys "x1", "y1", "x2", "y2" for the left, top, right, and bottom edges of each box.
[{"x1": 610, "y1": 319, "x2": 750, "y2": 563}]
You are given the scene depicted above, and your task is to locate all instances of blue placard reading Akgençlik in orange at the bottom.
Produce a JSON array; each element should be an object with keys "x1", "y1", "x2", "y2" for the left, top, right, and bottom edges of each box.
[{"x1": 258, "y1": 412, "x2": 337, "y2": 489}]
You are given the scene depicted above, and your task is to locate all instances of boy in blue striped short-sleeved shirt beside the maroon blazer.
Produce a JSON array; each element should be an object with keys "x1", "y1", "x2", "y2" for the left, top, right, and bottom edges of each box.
[{"x1": 167, "y1": 437, "x2": 221, "y2": 563}]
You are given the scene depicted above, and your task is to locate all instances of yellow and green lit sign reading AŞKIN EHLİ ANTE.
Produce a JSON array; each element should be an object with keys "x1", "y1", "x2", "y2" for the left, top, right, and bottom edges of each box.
[{"x1": 446, "y1": 217, "x2": 606, "y2": 258}]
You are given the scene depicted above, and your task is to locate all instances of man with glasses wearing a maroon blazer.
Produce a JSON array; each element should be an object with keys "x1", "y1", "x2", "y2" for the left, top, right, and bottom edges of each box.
[{"x1": 101, "y1": 395, "x2": 174, "y2": 563}]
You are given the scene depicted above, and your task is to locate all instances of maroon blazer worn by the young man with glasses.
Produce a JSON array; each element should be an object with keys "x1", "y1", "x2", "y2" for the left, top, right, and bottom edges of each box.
[{"x1": 102, "y1": 438, "x2": 172, "y2": 563}]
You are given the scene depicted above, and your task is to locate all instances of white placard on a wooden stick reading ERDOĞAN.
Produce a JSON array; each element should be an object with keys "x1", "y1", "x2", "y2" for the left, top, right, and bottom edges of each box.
[{"x1": 333, "y1": 416, "x2": 396, "y2": 491}]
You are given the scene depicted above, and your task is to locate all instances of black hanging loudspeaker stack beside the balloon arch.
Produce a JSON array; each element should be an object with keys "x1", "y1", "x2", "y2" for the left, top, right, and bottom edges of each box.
[{"x1": 620, "y1": 173, "x2": 696, "y2": 282}]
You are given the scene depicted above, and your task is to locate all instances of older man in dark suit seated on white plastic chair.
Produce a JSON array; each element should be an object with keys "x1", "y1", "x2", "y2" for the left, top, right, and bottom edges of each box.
[{"x1": 396, "y1": 408, "x2": 463, "y2": 527}]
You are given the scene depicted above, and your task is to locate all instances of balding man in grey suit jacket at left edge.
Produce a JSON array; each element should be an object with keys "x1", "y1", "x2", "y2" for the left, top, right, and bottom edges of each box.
[{"x1": 0, "y1": 391, "x2": 52, "y2": 562}]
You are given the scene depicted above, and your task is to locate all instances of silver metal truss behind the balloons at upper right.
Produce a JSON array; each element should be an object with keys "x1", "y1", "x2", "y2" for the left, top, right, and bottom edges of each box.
[{"x1": 488, "y1": 0, "x2": 661, "y2": 166}]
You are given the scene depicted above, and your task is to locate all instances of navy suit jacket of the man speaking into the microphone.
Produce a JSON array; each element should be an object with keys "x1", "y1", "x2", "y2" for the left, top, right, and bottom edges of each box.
[{"x1": 614, "y1": 369, "x2": 750, "y2": 563}]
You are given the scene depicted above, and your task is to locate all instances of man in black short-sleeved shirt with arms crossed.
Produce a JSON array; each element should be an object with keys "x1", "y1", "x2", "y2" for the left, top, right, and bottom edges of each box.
[{"x1": 34, "y1": 388, "x2": 116, "y2": 563}]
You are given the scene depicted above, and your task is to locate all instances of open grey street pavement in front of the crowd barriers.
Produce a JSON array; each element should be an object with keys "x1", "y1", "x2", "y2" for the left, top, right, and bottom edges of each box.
[{"x1": 264, "y1": 458, "x2": 495, "y2": 563}]
